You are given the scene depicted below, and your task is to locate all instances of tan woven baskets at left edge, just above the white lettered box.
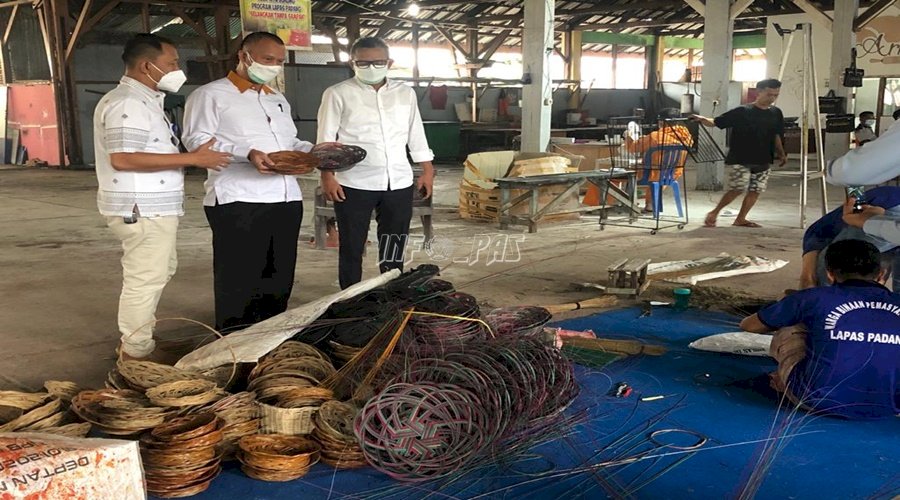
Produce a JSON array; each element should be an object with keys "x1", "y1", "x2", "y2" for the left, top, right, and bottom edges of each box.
[{"x1": 0, "y1": 380, "x2": 91, "y2": 437}]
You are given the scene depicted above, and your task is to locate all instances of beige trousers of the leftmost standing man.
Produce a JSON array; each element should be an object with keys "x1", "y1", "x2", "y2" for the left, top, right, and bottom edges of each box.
[{"x1": 106, "y1": 215, "x2": 178, "y2": 358}]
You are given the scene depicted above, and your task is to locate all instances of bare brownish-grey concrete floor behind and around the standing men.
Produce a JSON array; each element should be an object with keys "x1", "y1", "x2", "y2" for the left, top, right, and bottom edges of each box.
[{"x1": 0, "y1": 161, "x2": 842, "y2": 389}]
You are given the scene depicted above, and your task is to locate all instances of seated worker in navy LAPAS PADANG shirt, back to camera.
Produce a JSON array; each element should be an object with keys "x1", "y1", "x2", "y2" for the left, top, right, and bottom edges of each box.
[{"x1": 741, "y1": 240, "x2": 900, "y2": 420}]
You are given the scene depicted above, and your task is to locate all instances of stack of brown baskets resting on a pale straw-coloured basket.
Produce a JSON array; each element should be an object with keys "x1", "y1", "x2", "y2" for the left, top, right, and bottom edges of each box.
[{"x1": 248, "y1": 341, "x2": 336, "y2": 435}]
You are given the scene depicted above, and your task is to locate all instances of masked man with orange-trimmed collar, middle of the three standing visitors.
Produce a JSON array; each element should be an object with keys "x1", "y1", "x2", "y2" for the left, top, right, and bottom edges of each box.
[{"x1": 184, "y1": 32, "x2": 313, "y2": 330}]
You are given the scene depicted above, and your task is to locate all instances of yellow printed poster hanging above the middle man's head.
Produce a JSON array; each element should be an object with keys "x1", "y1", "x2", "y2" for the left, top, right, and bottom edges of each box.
[{"x1": 241, "y1": 0, "x2": 312, "y2": 50}]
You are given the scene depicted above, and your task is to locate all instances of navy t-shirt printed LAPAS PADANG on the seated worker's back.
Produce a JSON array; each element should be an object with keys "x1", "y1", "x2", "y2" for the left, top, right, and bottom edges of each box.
[{"x1": 759, "y1": 280, "x2": 900, "y2": 419}]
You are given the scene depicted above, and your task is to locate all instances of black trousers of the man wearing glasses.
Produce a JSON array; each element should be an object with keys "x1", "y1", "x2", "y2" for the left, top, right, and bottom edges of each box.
[{"x1": 334, "y1": 186, "x2": 414, "y2": 289}]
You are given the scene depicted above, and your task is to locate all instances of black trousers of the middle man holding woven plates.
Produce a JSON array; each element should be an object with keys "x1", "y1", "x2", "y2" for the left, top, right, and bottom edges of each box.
[{"x1": 205, "y1": 201, "x2": 303, "y2": 331}]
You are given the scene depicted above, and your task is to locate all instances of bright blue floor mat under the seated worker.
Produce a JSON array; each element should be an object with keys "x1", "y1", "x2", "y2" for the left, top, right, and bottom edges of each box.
[{"x1": 185, "y1": 308, "x2": 900, "y2": 499}]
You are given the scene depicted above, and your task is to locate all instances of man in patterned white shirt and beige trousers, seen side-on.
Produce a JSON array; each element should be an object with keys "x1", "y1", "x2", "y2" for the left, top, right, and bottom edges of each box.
[{"x1": 94, "y1": 35, "x2": 230, "y2": 359}]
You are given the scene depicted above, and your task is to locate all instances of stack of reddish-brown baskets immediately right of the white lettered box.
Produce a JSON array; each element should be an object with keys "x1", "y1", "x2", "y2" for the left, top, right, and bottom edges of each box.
[{"x1": 141, "y1": 413, "x2": 222, "y2": 498}]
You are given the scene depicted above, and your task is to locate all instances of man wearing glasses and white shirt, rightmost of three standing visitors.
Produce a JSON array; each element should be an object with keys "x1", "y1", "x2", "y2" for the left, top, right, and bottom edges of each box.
[{"x1": 317, "y1": 38, "x2": 434, "y2": 288}]
